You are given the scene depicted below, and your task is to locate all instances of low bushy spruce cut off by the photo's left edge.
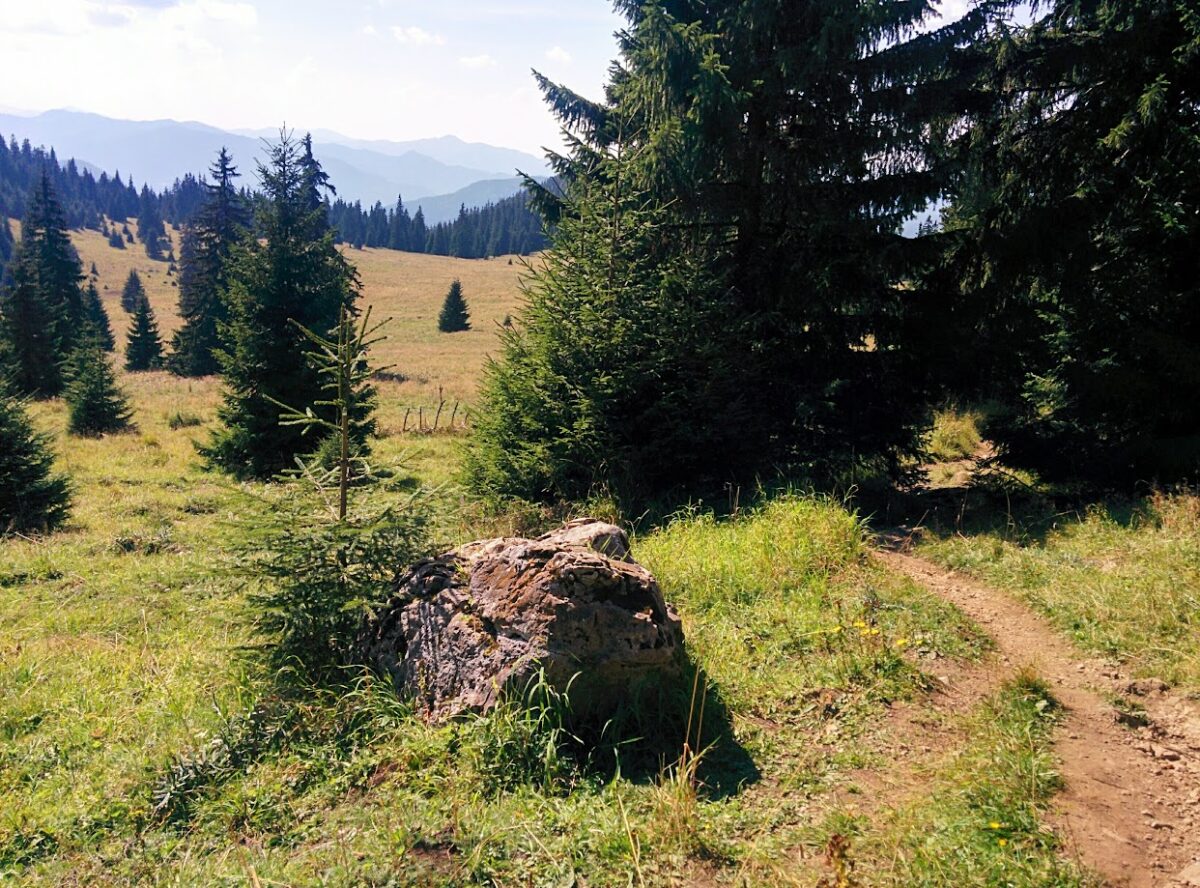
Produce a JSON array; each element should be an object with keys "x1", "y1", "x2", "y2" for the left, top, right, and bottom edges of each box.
[{"x1": 0, "y1": 380, "x2": 71, "y2": 534}]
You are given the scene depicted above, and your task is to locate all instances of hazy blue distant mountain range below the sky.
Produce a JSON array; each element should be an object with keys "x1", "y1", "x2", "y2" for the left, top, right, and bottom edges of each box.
[{"x1": 0, "y1": 110, "x2": 548, "y2": 224}]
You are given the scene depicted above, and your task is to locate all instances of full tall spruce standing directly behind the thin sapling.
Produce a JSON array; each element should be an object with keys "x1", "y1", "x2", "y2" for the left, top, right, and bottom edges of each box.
[{"x1": 203, "y1": 132, "x2": 359, "y2": 478}]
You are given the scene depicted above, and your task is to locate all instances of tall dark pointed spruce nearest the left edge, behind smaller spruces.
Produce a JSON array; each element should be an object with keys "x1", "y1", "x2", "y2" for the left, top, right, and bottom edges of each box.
[{"x1": 0, "y1": 173, "x2": 84, "y2": 397}]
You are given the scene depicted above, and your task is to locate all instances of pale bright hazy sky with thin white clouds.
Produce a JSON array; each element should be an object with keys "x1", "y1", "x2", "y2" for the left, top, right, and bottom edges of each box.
[{"x1": 0, "y1": 0, "x2": 966, "y2": 151}]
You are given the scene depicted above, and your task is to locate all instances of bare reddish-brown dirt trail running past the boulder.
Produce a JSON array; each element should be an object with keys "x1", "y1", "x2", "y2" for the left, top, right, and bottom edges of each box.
[{"x1": 878, "y1": 551, "x2": 1200, "y2": 888}]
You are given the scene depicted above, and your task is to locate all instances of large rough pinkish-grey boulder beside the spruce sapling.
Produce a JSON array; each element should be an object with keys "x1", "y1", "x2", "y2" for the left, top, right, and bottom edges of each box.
[{"x1": 360, "y1": 518, "x2": 683, "y2": 720}]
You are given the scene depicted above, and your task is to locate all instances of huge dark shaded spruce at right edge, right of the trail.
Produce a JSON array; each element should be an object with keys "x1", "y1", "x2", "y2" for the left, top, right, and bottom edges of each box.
[{"x1": 936, "y1": 0, "x2": 1200, "y2": 485}]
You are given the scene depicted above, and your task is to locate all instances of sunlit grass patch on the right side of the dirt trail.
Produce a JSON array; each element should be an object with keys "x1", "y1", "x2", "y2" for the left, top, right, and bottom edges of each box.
[{"x1": 920, "y1": 493, "x2": 1200, "y2": 694}]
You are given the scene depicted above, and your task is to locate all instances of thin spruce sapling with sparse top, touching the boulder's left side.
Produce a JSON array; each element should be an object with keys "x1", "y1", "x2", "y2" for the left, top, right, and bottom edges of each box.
[{"x1": 244, "y1": 308, "x2": 428, "y2": 677}]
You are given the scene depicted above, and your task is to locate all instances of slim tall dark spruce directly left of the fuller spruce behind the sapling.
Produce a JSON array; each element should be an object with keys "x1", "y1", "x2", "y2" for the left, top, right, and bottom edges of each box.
[{"x1": 168, "y1": 149, "x2": 250, "y2": 377}]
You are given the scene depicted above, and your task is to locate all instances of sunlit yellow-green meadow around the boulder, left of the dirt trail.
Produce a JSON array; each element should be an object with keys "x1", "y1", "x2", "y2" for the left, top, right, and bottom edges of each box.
[{"x1": 0, "y1": 226, "x2": 1180, "y2": 888}]
